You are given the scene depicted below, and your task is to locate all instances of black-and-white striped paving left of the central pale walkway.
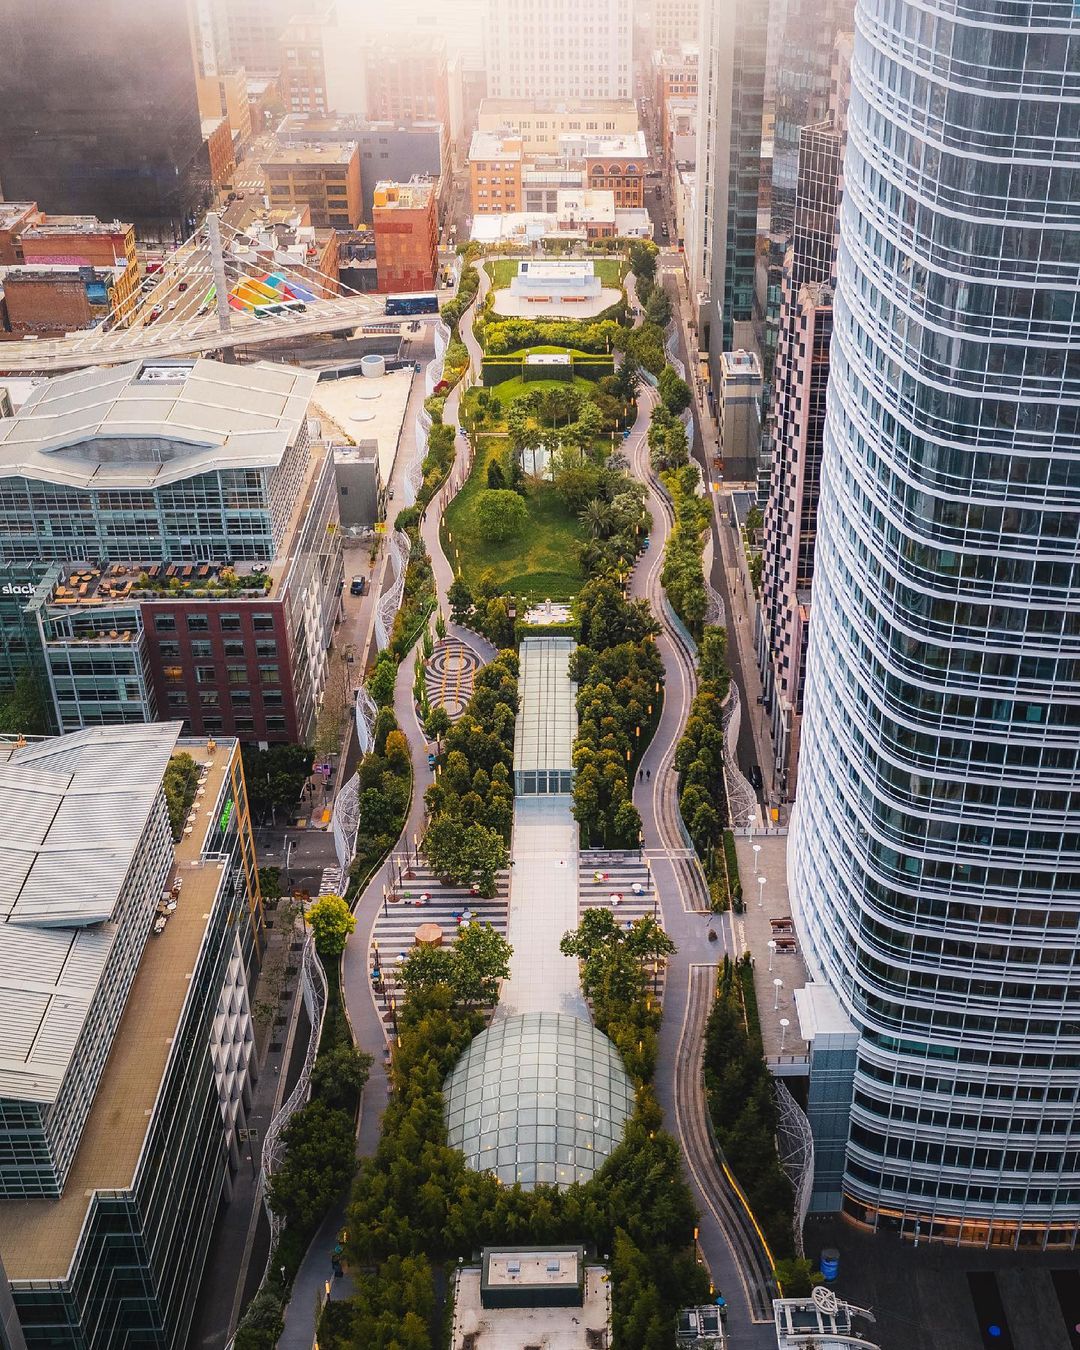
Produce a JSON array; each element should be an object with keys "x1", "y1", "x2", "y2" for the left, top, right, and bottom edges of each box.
[{"x1": 369, "y1": 855, "x2": 509, "y2": 1025}]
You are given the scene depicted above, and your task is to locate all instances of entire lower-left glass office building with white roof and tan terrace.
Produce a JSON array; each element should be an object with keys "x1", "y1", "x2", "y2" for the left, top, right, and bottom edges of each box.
[{"x1": 0, "y1": 724, "x2": 263, "y2": 1350}]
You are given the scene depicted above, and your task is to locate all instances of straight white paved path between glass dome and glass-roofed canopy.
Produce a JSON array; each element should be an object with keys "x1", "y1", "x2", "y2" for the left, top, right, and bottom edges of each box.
[{"x1": 497, "y1": 794, "x2": 590, "y2": 1022}]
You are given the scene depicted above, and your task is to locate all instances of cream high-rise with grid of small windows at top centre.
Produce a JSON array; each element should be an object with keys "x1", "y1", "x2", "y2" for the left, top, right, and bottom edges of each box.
[{"x1": 486, "y1": 0, "x2": 633, "y2": 99}]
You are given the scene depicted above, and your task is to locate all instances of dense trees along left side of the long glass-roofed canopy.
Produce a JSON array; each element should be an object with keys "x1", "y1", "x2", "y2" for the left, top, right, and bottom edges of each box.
[{"x1": 423, "y1": 651, "x2": 518, "y2": 895}]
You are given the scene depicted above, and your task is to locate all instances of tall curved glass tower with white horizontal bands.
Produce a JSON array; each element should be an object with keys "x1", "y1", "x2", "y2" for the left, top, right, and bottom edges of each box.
[{"x1": 790, "y1": 0, "x2": 1080, "y2": 1246}]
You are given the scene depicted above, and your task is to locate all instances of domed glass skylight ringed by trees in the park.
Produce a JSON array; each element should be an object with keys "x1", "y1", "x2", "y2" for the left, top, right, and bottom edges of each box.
[{"x1": 443, "y1": 1013, "x2": 635, "y2": 1191}]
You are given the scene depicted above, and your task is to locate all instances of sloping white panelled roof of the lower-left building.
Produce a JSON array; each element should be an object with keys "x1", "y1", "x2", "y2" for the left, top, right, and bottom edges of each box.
[{"x1": 0, "y1": 722, "x2": 180, "y2": 1102}]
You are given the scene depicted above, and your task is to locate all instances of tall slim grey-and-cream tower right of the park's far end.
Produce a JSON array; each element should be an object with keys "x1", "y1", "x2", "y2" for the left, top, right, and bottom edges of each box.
[{"x1": 690, "y1": 0, "x2": 770, "y2": 375}]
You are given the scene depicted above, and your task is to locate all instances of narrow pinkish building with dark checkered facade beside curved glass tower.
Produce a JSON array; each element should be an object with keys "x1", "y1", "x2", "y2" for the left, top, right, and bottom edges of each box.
[{"x1": 756, "y1": 117, "x2": 844, "y2": 799}]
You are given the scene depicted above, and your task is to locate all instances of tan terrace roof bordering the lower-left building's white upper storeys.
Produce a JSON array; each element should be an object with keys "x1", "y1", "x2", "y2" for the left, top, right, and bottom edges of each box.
[{"x1": 0, "y1": 725, "x2": 232, "y2": 1280}]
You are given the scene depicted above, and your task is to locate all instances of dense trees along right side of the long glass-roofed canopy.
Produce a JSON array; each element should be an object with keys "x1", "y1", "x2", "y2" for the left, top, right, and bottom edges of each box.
[{"x1": 570, "y1": 578, "x2": 664, "y2": 848}]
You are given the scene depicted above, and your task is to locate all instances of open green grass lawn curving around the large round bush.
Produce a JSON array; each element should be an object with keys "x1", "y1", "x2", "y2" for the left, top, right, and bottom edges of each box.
[{"x1": 441, "y1": 436, "x2": 585, "y2": 599}]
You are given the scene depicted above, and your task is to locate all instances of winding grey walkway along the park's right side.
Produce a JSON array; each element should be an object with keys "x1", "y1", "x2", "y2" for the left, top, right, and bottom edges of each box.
[{"x1": 624, "y1": 372, "x2": 776, "y2": 1350}]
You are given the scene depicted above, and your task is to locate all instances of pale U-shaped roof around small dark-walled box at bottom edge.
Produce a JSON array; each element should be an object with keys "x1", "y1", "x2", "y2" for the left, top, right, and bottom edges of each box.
[{"x1": 450, "y1": 1265, "x2": 612, "y2": 1350}]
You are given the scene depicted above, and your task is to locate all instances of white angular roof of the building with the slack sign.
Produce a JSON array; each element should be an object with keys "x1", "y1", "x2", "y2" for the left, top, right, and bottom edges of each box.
[{"x1": 0, "y1": 356, "x2": 317, "y2": 489}]
